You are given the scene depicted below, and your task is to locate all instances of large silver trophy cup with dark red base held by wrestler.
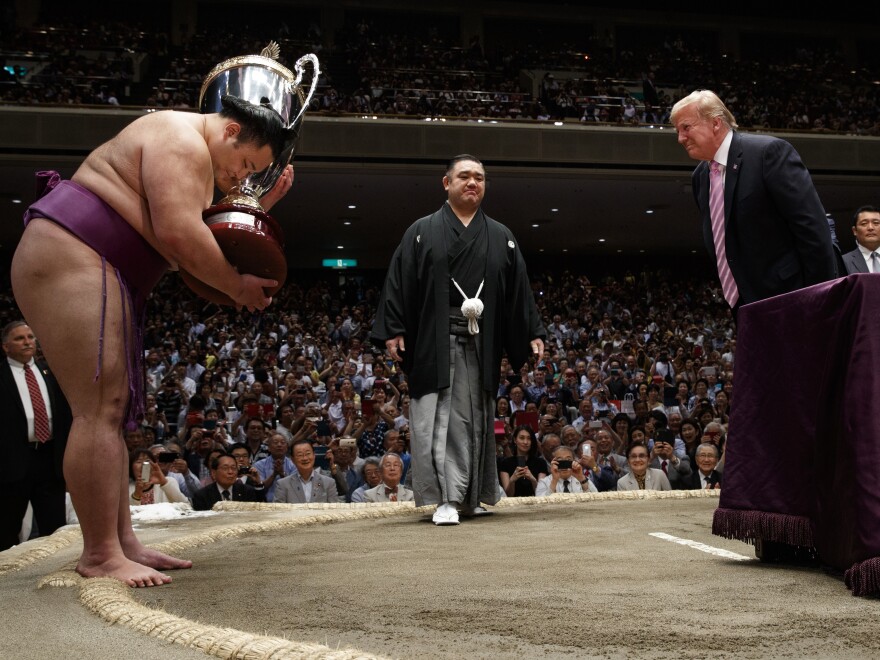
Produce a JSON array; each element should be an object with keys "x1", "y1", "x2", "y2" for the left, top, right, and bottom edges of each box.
[{"x1": 181, "y1": 42, "x2": 320, "y2": 305}]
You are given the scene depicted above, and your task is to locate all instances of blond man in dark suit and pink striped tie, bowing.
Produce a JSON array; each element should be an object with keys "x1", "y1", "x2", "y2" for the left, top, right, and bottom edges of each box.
[{"x1": 671, "y1": 90, "x2": 837, "y2": 309}]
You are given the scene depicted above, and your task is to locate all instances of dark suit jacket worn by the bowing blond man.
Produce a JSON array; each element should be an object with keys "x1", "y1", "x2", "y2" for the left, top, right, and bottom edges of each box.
[{"x1": 693, "y1": 131, "x2": 837, "y2": 305}]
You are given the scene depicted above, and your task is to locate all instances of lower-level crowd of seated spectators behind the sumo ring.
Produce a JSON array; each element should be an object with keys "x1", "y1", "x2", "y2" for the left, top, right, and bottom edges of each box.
[{"x1": 0, "y1": 260, "x2": 735, "y2": 508}]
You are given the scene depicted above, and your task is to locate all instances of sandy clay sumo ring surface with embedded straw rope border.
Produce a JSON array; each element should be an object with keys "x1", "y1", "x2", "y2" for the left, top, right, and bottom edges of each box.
[{"x1": 0, "y1": 496, "x2": 880, "y2": 659}]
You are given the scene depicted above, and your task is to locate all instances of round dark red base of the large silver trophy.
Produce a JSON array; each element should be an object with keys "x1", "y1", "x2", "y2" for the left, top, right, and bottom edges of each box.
[{"x1": 180, "y1": 204, "x2": 287, "y2": 306}]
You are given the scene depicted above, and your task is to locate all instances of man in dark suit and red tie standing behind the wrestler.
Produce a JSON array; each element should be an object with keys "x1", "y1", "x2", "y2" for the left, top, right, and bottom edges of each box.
[{"x1": 0, "y1": 321, "x2": 71, "y2": 550}]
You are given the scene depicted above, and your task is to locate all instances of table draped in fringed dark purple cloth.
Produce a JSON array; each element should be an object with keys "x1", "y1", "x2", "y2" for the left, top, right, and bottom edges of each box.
[{"x1": 712, "y1": 274, "x2": 880, "y2": 596}]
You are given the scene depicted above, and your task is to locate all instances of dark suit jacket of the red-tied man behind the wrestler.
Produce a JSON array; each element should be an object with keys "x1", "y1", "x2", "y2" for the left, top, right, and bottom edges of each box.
[{"x1": 0, "y1": 360, "x2": 72, "y2": 483}]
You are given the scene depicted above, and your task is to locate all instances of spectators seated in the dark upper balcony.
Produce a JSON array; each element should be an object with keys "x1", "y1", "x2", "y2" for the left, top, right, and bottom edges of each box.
[{"x1": 0, "y1": 12, "x2": 880, "y2": 135}]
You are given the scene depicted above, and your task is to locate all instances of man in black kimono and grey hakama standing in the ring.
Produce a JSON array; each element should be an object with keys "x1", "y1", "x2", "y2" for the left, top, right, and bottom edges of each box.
[{"x1": 372, "y1": 154, "x2": 546, "y2": 525}]
